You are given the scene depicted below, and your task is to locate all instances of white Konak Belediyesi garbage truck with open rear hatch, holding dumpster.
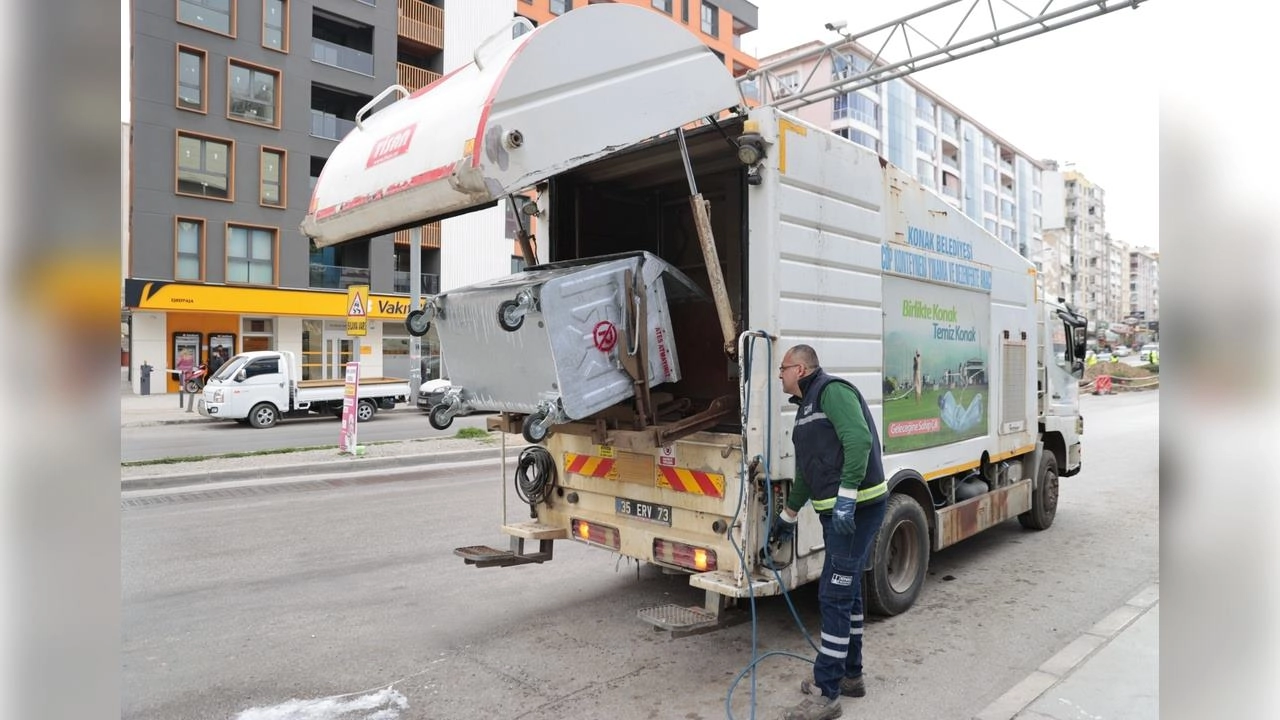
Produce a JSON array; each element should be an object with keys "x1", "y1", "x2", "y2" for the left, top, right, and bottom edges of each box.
[{"x1": 302, "y1": 4, "x2": 1085, "y2": 633}]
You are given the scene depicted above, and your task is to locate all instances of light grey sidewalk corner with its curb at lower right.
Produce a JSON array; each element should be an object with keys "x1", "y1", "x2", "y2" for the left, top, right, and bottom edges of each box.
[{"x1": 974, "y1": 583, "x2": 1160, "y2": 720}]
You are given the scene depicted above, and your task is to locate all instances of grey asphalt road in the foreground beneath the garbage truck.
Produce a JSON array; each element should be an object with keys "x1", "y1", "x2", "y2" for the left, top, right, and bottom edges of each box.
[{"x1": 120, "y1": 392, "x2": 1160, "y2": 720}]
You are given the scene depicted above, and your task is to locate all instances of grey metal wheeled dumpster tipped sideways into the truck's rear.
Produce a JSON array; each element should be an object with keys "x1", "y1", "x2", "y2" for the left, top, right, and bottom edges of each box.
[{"x1": 410, "y1": 252, "x2": 705, "y2": 442}]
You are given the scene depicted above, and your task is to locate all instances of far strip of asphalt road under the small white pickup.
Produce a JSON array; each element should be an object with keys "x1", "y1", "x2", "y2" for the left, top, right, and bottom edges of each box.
[{"x1": 120, "y1": 407, "x2": 485, "y2": 462}]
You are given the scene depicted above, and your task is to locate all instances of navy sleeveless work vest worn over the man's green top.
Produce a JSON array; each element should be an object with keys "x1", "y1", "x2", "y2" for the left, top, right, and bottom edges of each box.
[{"x1": 791, "y1": 368, "x2": 884, "y2": 502}]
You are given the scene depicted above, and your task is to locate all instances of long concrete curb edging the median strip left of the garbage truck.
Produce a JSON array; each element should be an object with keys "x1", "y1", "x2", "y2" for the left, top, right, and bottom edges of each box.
[{"x1": 120, "y1": 446, "x2": 506, "y2": 492}]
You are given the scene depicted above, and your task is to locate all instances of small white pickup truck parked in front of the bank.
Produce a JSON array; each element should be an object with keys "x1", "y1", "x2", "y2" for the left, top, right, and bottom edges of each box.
[{"x1": 200, "y1": 350, "x2": 410, "y2": 428}]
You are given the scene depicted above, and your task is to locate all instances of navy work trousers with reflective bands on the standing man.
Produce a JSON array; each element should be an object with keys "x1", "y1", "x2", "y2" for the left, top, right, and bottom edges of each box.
[{"x1": 813, "y1": 498, "x2": 886, "y2": 697}]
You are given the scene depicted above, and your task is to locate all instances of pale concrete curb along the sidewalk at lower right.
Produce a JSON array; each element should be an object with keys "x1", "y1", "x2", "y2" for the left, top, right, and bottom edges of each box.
[{"x1": 973, "y1": 583, "x2": 1160, "y2": 720}]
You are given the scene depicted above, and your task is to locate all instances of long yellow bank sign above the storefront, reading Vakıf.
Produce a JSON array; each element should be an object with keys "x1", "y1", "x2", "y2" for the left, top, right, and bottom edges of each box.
[{"x1": 124, "y1": 278, "x2": 408, "y2": 319}]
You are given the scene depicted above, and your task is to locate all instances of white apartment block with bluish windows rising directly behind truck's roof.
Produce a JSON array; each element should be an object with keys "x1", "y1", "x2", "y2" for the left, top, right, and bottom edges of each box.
[{"x1": 750, "y1": 42, "x2": 1043, "y2": 259}]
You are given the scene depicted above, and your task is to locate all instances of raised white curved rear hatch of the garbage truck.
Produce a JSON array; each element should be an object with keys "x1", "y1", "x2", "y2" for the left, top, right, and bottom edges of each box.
[{"x1": 302, "y1": 4, "x2": 741, "y2": 247}]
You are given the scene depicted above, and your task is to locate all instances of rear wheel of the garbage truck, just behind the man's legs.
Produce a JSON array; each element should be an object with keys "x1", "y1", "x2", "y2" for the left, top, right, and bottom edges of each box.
[{"x1": 867, "y1": 493, "x2": 929, "y2": 615}]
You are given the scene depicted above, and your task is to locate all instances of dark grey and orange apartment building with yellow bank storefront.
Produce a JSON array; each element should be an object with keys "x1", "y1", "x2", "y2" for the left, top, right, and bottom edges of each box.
[{"x1": 122, "y1": 0, "x2": 756, "y2": 392}]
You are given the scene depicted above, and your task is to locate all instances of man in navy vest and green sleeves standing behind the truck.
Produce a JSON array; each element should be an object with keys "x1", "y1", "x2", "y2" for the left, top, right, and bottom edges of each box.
[{"x1": 772, "y1": 345, "x2": 888, "y2": 720}]
